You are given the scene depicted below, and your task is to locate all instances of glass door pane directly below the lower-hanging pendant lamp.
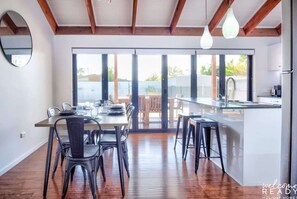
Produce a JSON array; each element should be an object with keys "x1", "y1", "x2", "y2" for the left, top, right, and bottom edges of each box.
[{"x1": 197, "y1": 55, "x2": 219, "y2": 99}]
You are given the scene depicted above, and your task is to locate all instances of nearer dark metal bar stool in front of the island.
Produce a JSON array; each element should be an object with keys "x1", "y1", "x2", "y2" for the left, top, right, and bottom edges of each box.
[{"x1": 186, "y1": 117, "x2": 225, "y2": 173}]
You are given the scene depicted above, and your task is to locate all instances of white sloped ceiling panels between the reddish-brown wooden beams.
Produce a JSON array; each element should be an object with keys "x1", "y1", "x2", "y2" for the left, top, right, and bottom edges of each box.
[{"x1": 47, "y1": 0, "x2": 281, "y2": 28}]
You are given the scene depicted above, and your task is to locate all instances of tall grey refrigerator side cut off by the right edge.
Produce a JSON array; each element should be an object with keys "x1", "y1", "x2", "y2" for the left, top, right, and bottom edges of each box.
[{"x1": 280, "y1": 0, "x2": 297, "y2": 193}]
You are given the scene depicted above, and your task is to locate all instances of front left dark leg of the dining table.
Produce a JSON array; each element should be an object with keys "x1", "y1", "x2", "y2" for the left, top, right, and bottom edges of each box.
[{"x1": 43, "y1": 128, "x2": 54, "y2": 198}]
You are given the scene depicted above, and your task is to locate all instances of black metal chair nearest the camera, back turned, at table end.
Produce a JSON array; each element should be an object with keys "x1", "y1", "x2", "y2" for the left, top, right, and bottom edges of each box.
[{"x1": 54, "y1": 116, "x2": 105, "y2": 198}]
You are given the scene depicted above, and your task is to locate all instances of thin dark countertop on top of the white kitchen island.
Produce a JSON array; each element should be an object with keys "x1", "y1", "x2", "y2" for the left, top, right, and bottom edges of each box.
[{"x1": 176, "y1": 98, "x2": 281, "y2": 109}]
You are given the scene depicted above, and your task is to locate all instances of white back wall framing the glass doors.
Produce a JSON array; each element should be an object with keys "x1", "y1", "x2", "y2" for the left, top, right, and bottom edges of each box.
[{"x1": 54, "y1": 35, "x2": 280, "y2": 106}]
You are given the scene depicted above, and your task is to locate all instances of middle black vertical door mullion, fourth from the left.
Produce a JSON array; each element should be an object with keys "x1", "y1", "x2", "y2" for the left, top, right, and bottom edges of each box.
[{"x1": 161, "y1": 55, "x2": 168, "y2": 130}]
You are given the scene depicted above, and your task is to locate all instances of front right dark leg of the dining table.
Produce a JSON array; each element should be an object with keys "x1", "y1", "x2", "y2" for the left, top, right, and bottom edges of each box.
[{"x1": 115, "y1": 126, "x2": 125, "y2": 196}]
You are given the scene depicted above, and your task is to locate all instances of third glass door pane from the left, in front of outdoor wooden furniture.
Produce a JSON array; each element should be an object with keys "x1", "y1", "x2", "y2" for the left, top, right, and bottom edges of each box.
[{"x1": 138, "y1": 55, "x2": 162, "y2": 129}]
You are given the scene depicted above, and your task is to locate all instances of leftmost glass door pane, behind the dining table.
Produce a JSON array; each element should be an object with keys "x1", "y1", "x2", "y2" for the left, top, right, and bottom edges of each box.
[{"x1": 77, "y1": 54, "x2": 102, "y2": 105}]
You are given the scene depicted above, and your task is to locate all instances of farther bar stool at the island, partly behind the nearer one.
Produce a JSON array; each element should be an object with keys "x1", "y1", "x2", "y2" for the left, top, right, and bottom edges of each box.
[{"x1": 174, "y1": 113, "x2": 201, "y2": 157}]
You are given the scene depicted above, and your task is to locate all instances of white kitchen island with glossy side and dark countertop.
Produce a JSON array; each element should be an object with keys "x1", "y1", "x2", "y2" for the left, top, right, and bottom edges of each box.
[{"x1": 178, "y1": 98, "x2": 281, "y2": 186}]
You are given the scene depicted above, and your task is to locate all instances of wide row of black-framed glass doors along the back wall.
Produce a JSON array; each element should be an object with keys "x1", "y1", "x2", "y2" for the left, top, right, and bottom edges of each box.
[{"x1": 73, "y1": 50, "x2": 252, "y2": 131}]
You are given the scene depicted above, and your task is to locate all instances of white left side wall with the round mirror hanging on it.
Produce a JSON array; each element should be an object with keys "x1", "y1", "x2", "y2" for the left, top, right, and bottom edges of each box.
[{"x1": 0, "y1": 0, "x2": 53, "y2": 175}]
